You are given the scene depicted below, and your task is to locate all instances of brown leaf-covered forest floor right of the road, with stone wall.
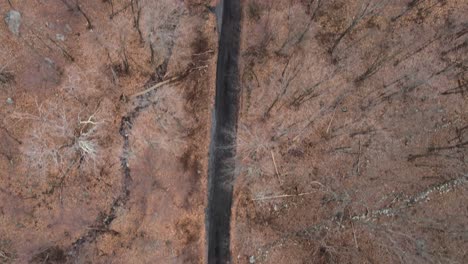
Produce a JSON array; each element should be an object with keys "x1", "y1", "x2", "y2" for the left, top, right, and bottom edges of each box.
[{"x1": 231, "y1": 0, "x2": 468, "y2": 264}]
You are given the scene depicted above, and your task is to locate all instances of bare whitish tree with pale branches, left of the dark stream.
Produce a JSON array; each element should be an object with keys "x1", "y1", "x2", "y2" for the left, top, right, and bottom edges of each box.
[{"x1": 12, "y1": 102, "x2": 105, "y2": 177}]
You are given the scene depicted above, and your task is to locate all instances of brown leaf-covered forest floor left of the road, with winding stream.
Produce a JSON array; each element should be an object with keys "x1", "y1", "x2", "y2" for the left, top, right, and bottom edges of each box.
[{"x1": 0, "y1": 0, "x2": 217, "y2": 263}]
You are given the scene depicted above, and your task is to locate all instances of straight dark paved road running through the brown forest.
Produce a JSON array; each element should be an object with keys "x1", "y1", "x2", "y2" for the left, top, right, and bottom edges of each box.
[{"x1": 205, "y1": 0, "x2": 241, "y2": 263}]
